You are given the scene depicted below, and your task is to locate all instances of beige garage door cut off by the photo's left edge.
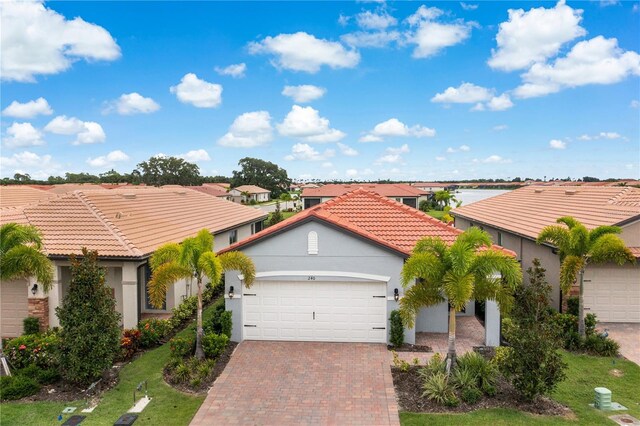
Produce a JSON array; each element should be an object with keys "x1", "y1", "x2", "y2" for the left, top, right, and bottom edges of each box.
[{"x1": 0, "y1": 280, "x2": 29, "y2": 337}]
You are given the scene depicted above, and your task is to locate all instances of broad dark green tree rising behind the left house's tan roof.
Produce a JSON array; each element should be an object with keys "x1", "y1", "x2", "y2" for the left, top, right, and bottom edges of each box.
[{"x1": 138, "y1": 156, "x2": 202, "y2": 186}]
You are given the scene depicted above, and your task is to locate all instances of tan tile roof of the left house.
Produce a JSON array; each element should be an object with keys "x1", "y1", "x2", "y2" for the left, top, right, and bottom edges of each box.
[{"x1": 0, "y1": 187, "x2": 266, "y2": 257}]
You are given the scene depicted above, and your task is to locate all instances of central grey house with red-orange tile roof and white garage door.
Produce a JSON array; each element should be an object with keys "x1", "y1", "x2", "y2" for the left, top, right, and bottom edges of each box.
[{"x1": 221, "y1": 188, "x2": 508, "y2": 345}]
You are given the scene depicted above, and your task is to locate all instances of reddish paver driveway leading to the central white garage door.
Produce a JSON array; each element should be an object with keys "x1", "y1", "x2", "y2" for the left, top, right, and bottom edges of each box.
[{"x1": 191, "y1": 341, "x2": 399, "y2": 426}]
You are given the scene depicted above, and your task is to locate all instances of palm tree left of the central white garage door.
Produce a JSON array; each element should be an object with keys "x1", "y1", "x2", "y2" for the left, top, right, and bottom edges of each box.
[{"x1": 148, "y1": 229, "x2": 255, "y2": 359}]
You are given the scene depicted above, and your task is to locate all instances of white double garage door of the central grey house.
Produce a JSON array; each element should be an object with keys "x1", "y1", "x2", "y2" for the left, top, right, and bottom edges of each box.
[{"x1": 242, "y1": 281, "x2": 387, "y2": 343}]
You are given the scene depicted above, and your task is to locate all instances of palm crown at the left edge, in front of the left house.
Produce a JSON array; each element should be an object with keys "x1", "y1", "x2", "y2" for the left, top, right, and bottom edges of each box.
[{"x1": 0, "y1": 223, "x2": 53, "y2": 291}]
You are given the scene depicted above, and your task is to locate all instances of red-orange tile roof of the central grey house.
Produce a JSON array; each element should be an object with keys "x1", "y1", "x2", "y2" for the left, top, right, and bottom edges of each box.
[{"x1": 221, "y1": 188, "x2": 514, "y2": 255}]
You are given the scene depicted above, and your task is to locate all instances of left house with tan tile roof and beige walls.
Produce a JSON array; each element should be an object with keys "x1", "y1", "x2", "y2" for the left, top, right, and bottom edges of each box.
[{"x1": 0, "y1": 187, "x2": 266, "y2": 337}]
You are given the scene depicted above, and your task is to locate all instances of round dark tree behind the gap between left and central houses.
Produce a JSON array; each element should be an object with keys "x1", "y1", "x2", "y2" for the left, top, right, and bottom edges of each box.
[{"x1": 231, "y1": 157, "x2": 291, "y2": 198}]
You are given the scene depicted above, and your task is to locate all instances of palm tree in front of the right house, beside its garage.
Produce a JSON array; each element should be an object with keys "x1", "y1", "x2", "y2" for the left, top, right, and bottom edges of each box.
[{"x1": 537, "y1": 216, "x2": 635, "y2": 337}]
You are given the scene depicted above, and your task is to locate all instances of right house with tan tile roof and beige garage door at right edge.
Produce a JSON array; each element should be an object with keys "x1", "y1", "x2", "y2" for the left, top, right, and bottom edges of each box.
[{"x1": 452, "y1": 185, "x2": 640, "y2": 322}]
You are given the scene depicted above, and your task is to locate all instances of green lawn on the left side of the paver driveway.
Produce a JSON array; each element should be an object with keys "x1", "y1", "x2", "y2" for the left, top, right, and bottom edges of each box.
[{"x1": 0, "y1": 305, "x2": 225, "y2": 426}]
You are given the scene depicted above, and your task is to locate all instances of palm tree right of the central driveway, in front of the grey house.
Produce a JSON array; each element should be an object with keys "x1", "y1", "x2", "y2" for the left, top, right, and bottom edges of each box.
[{"x1": 400, "y1": 227, "x2": 522, "y2": 371}]
